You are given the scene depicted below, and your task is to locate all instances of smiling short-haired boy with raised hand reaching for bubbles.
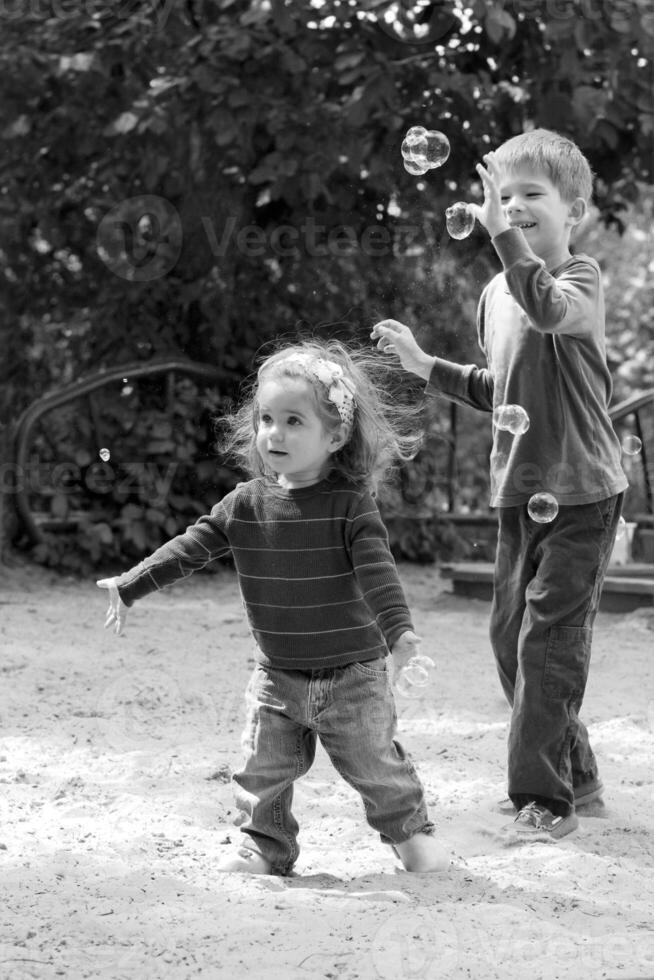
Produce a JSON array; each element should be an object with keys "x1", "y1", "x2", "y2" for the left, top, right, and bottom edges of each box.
[{"x1": 372, "y1": 129, "x2": 627, "y2": 840}]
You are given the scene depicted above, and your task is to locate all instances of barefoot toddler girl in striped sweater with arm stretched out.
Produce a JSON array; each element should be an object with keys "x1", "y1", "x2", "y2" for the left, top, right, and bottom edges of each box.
[{"x1": 97, "y1": 341, "x2": 449, "y2": 875}]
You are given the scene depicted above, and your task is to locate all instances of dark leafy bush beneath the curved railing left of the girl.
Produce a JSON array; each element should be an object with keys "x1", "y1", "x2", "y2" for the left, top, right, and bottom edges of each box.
[{"x1": 24, "y1": 378, "x2": 239, "y2": 573}]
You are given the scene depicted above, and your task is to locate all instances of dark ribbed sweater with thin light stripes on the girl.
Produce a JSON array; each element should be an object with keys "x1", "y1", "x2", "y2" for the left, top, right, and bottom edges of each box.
[{"x1": 111, "y1": 477, "x2": 413, "y2": 670}]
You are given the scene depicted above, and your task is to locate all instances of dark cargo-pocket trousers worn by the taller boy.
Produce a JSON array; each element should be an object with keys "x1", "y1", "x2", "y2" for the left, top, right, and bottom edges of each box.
[{"x1": 490, "y1": 494, "x2": 623, "y2": 816}]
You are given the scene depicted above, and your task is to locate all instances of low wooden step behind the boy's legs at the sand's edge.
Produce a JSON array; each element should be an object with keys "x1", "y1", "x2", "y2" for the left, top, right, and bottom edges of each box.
[{"x1": 440, "y1": 561, "x2": 654, "y2": 612}]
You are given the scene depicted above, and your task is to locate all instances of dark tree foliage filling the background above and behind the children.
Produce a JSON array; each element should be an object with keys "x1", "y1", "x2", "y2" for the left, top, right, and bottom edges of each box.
[{"x1": 0, "y1": 0, "x2": 654, "y2": 570}]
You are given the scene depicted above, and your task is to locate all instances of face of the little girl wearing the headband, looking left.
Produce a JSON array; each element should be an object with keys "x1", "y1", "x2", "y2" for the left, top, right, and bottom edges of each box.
[{"x1": 257, "y1": 376, "x2": 344, "y2": 489}]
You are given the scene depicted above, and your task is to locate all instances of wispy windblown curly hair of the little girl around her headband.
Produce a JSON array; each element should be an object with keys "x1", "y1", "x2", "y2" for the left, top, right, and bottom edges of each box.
[{"x1": 218, "y1": 339, "x2": 422, "y2": 492}]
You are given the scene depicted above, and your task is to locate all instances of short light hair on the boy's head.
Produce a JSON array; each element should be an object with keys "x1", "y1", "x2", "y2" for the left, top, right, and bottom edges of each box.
[{"x1": 496, "y1": 129, "x2": 593, "y2": 202}]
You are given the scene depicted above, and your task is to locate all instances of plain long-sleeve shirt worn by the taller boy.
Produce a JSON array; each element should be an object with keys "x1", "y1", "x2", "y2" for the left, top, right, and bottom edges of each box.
[{"x1": 428, "y1": 229, "x2": 628, "y2": 507}]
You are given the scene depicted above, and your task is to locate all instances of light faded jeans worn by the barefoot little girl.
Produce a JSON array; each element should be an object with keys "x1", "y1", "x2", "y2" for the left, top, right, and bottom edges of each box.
[{"x1": 234, "y1": 658, "x2": 433, "y2": 875}]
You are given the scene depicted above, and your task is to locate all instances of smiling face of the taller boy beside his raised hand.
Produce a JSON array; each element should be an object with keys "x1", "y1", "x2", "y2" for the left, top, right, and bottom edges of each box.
[{"x1": 500, "y1": 167, "x2": 586, "y2": 269}]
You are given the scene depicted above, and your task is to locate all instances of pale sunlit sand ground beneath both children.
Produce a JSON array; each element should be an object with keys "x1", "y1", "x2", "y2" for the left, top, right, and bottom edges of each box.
[{"x1": 0, "y1": 565, "x2": 654, "y2": 980}]
